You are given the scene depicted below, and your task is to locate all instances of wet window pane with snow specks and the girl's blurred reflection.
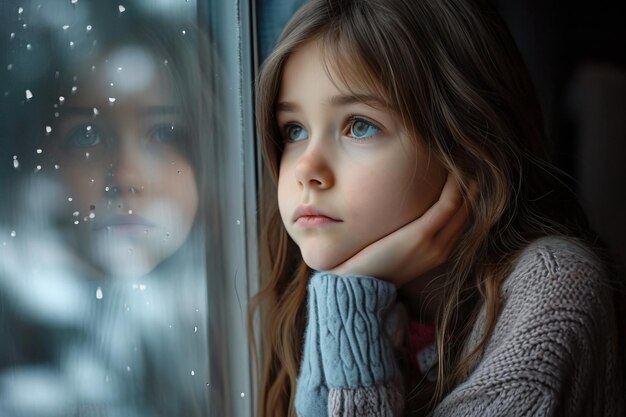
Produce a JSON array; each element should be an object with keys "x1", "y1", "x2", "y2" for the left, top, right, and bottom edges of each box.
[{"x1": 0, "y1": 0, "x2": 219, "y2": 417}]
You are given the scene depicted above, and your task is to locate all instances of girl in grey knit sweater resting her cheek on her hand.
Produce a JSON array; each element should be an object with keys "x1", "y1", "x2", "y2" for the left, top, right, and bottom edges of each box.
[{"x1": 253, "y1": 0, "x2": 623, "y2": 417}]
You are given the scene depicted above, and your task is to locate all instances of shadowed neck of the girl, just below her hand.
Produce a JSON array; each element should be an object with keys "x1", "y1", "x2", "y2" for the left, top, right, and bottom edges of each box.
[{"x1": 398, "y1": 264, "x2": 450, "y2": 323}]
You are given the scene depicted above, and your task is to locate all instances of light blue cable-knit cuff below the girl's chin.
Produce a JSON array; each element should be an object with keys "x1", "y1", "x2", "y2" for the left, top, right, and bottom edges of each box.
[{"x1": 305, "y1": 272, "x2": 396, "y2": 388}]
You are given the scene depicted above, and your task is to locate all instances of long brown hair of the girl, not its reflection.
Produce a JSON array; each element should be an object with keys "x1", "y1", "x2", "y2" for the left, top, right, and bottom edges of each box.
[{"x1": 251, "y1": 0, "x2": 584, "y2": 417}]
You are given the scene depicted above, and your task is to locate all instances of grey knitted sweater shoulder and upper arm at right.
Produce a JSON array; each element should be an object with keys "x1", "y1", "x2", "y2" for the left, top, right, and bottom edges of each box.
[{"x1": 435, "y1": 237, "x2": 623, "y2": 416}]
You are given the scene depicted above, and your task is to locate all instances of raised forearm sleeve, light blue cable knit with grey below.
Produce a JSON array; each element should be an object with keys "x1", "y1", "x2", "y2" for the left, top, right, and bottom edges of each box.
[{"x1": 295, "y1": 272, "x2": 401, "y2": 417}]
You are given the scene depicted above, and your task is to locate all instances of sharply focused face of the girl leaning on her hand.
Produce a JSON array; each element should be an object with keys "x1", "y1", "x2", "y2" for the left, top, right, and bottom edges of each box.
[{"x1": 276, "y1": 43, "x2": 446, "y2": 270}]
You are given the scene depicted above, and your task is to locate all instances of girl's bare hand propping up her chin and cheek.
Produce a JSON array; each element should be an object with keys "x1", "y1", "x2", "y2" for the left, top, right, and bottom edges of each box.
[{"x1": 330, "y1": 174, "x2": 476, "y2": 286}]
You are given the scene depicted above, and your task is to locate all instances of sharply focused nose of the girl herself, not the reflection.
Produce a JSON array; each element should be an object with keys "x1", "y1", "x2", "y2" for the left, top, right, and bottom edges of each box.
[{"x1": 294, "y1": 142, "x2": 335, "y2": 190}]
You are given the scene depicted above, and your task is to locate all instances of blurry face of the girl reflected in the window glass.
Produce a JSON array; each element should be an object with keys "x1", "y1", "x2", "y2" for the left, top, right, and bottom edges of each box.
[{"x1": 51, "y1": 49, "x2": 198, "y2": 276}]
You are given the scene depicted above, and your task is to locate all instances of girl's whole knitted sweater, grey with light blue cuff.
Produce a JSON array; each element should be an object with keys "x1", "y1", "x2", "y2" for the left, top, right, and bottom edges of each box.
[{"x1": 295, "y1": 237, "x2": 624, "y2": 417}]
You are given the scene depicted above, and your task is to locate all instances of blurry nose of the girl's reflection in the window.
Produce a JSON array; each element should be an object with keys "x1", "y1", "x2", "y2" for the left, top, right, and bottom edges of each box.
[{"x1": 107, "y1": 142, "x2": 147, "y2": 198}]
